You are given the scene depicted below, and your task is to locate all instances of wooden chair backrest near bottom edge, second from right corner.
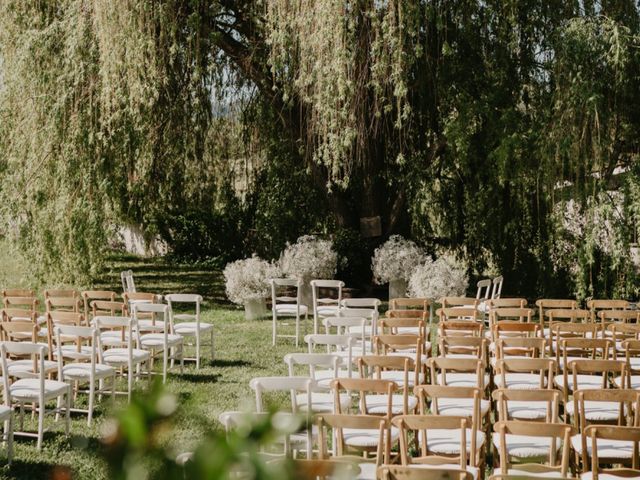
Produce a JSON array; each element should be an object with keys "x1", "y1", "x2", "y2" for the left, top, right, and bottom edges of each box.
[{"x1": 493, "y1": 421, "x2": 574, "y2": 477}]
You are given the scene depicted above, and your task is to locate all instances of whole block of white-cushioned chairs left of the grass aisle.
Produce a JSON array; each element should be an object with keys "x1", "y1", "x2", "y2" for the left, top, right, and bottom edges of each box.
[{"x1": 0, "y1": 282, "x2": 214, "y2": 462}]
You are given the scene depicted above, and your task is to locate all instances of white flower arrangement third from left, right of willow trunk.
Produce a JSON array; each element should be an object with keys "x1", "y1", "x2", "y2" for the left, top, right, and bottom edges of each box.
[{"x1": 371, "y1": 235, "x2": 429, "y2": 285}]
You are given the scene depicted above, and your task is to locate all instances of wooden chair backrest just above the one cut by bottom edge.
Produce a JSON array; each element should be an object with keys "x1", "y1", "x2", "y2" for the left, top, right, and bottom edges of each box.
[{"x1": 391, "y1": 415, "x2": 477, "y2": 469}]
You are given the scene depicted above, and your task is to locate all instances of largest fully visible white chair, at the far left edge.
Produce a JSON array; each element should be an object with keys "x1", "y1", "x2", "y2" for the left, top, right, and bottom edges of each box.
[{"x1": 0, "y1": 342, "x2": 71, "y2": 450}]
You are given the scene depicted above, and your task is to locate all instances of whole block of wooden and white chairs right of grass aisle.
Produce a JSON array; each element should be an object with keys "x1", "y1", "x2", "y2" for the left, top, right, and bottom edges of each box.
[{"x1": 220, "y1": 278, "x2": 640, "y2": 479}]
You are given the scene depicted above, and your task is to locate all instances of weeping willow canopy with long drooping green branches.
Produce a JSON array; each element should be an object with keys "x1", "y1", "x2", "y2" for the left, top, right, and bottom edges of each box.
[{"x1": 0, "y1": 0, "x2": 640, "y2": 297}]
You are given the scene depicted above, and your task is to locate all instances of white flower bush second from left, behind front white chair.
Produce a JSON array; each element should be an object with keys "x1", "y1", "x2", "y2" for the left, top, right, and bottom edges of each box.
[{"x1": 280, "y1": 235, "x2": 338, "y2": 281}]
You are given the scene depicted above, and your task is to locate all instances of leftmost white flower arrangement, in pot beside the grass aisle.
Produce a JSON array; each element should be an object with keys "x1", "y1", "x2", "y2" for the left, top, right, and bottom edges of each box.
[{"x1": 223, "y1": 255, "x2": 280, "y2": 305}]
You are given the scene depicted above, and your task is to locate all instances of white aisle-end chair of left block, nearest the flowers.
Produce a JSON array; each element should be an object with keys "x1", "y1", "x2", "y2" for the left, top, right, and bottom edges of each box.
[{"x1": 164, "y1": 293, "x2": 214, "y2": 368}]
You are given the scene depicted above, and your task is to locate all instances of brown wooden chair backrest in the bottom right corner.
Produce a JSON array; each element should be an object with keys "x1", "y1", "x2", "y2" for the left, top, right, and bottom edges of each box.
[{"x1": 584, "y1": 425, "x2": 640, "y2": 474}]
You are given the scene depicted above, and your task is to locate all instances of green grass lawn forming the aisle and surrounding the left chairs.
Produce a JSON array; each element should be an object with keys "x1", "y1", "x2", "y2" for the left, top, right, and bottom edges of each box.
[{"x1": 0, "y1": 256, "x2": 311, "y2": 479}]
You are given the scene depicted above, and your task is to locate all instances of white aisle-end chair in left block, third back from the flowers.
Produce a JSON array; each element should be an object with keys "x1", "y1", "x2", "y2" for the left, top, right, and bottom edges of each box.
[{"x1": 93, "y1": 315, "x2": 151, "y2": 401}]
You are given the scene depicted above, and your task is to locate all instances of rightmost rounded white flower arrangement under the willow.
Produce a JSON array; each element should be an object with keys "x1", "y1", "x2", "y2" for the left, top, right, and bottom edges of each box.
[{"x1": 409, "y1": 255, "x2": 469, "y2": 300}]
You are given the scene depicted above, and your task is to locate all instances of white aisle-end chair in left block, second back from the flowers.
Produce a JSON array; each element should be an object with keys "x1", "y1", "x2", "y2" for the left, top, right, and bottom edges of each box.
[{"x1": 133, "y1": 303, "x2": 184, "y2": 383}]
